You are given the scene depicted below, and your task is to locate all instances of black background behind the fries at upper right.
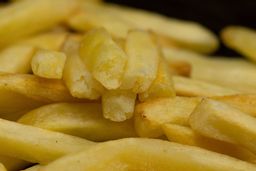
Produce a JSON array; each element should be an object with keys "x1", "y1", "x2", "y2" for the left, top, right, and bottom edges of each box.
[{"x1": 0, "y1": 0, "x2": 256, "y2": 56}]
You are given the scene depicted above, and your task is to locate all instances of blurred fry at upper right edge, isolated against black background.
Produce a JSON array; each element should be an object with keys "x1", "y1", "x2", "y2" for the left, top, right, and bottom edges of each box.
[{"x1": 221, "y1": 26, "x2": 256, "y2": 62}]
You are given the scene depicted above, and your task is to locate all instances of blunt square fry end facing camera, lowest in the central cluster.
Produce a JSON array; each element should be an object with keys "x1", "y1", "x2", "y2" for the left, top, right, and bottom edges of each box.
[{"x1": 102, "y1": 90, "x2": 137, "y2": 122}]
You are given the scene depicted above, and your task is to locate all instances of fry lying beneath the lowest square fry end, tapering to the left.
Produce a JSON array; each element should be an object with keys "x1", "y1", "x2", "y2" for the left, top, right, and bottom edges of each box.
[{"x1": 18, "y1": 103, "x2": 136, "y2": 141}]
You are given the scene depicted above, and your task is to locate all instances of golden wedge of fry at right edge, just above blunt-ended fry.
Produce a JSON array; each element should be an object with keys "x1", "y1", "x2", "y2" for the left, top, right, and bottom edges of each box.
[{"x1": 212, "y1": 94, "x2": 256, "y2": 117}]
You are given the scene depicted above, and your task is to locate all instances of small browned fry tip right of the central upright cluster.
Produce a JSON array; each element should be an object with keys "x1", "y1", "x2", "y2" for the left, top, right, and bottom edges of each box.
[{"x1": 169, "y1": 60, "x2": 192, "y2": 77}]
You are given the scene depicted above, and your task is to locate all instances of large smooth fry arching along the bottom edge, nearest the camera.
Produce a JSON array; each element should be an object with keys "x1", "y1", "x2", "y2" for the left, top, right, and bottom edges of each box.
[{"x1": 41, "y1": 139, "x2": 256, "y2": 171}]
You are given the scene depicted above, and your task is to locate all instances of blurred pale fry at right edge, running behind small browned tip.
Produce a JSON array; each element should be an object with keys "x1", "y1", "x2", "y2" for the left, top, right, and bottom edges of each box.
[{"x1": 163, "y1": 48, "x2": 256, "y2": 93}]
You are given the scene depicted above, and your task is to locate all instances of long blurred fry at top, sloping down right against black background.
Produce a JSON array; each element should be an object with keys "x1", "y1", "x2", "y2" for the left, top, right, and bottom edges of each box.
[{"x1": 69, "y1": 3, "x2": 218, "y2": 53}]
